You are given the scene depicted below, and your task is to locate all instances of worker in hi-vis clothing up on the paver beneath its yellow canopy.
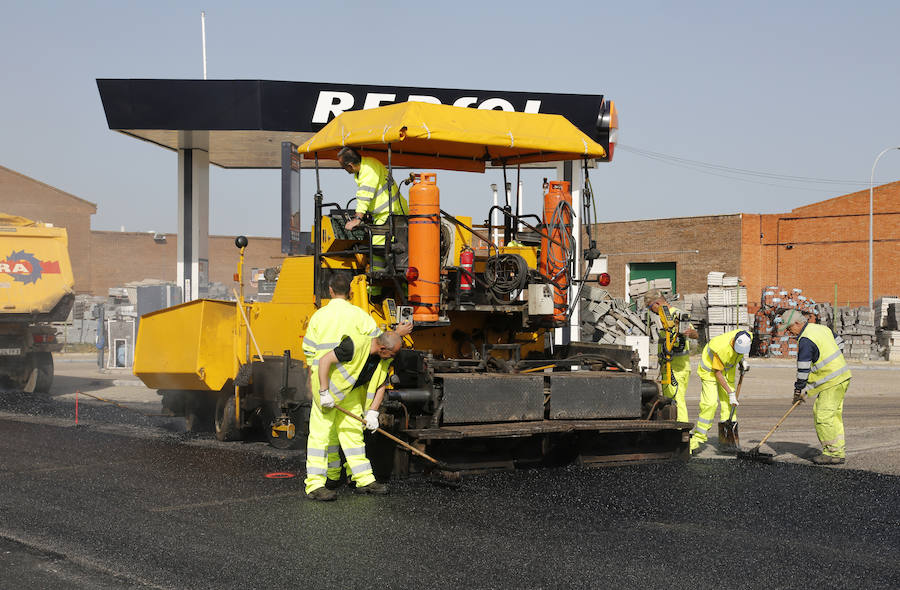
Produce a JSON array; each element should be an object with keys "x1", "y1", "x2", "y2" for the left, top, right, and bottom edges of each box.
[{"x1": 337, "y1": 147, "x2": 409, "y2": 286}]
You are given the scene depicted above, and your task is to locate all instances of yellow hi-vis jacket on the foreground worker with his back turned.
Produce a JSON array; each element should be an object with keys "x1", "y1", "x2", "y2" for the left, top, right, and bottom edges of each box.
[{"x1": 303, "y1": 299, "x2": 381, "y2": 400}]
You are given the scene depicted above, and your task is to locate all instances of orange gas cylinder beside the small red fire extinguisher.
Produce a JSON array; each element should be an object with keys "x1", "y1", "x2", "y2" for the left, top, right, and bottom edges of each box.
[{"x1": 406, "y1": 172, "x2": 441, "y2": 322}]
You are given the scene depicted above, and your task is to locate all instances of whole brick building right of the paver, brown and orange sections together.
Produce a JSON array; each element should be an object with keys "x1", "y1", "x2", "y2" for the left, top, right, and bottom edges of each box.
[{"x1": 594, "y1": 181, "x2": 900, "y2": 306}]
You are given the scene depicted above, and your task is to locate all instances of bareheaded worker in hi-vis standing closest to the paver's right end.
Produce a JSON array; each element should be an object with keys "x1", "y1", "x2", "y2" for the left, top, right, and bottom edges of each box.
[{"x1": 644, "y1": 289, "x2": 697, "y2": 422}]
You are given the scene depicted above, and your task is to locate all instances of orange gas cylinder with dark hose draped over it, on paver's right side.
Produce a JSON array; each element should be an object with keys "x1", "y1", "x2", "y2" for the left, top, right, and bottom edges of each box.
[{"x1": 538, "y1": 180, "x2": 575, "y2": 321}]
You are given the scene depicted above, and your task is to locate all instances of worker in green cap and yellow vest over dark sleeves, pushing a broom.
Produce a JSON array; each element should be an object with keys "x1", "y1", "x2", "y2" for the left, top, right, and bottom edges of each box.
[{"x1": 778, "y1": 309, "x2": 850, "y2": 465}]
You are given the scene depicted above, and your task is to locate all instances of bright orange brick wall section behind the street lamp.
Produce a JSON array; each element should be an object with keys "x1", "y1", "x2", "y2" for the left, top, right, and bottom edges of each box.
[{"x1": 741, "y1": 182, "x2": 900, "y2": 306}]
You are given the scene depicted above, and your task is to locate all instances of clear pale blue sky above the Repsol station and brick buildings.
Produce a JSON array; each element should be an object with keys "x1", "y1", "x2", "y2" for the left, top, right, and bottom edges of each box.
[{"x1": 0, "y1": 0, "x2": 900, "y2": 236}]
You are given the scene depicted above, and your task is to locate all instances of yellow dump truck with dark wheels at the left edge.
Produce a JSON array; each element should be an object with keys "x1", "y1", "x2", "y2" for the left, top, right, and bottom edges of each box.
[{"x1": 0, "y1": 213, "x2": 75, "y2": 393}]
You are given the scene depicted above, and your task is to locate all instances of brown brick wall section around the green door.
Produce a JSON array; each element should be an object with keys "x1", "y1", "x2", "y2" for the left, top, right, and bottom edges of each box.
[{"x1": 585, "y1": 215, "x2": 742, "y2": 297}]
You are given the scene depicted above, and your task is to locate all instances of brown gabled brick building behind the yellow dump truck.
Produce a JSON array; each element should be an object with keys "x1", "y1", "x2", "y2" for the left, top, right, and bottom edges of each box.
[{"x1": 0, "y1": 166, "x2": 97, "y2": 293}]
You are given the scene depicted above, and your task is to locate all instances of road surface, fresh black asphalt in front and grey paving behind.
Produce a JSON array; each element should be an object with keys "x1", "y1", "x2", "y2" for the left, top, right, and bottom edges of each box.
[{"x1": 0, "y1": 363, "x2": 900, "y2": 589}]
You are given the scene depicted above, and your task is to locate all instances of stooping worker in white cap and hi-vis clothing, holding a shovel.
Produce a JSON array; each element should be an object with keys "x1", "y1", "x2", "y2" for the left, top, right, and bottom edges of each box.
[{"x1": 691, "y1": 330, "x2": 753, "y2": 453}]
